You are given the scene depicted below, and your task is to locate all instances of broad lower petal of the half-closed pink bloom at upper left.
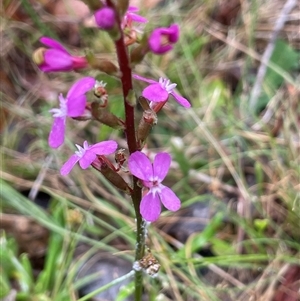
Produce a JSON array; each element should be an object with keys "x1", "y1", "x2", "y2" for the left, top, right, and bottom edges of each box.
[{"x1": 40, "y1": 49, "x2": 73, "y2": 71}]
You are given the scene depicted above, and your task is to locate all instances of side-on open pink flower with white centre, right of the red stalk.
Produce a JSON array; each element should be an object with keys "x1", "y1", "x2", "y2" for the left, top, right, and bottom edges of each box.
[{"x1": 133, "y1": 74, "x2": 191, "y2": 108}]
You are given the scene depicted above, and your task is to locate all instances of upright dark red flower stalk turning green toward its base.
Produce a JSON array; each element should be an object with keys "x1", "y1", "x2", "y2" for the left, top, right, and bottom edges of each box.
[{"x1": 107, "y1": 1, "x2": 145, "y2": 301}]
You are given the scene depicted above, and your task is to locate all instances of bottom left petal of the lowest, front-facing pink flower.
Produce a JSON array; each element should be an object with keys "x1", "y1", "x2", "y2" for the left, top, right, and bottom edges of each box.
[{"x1": 140, "y1": 192, "x2": 161, "y2": 222}]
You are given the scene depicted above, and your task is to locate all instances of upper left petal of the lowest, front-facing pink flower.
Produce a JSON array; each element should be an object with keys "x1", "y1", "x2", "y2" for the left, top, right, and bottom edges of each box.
[{"x1": 128, "y1": 151, "x2": 153, "y2": 181}]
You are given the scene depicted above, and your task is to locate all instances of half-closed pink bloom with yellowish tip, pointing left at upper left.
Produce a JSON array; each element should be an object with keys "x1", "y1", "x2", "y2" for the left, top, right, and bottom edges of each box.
[{"x1": 35, "y1": 37, "x2": 88, "y2": 72}]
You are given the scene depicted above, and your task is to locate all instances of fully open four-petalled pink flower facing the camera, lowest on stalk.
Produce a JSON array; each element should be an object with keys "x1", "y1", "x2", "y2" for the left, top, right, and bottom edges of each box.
[{"x1": 128, "y1": 151, "x2": 180, "y2": 222}]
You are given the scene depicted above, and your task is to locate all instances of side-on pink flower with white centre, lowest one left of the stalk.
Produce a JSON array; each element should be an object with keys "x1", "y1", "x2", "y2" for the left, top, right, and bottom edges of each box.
[{"x1": 60, "y1": 140, "x2": 118, "y2": 176}]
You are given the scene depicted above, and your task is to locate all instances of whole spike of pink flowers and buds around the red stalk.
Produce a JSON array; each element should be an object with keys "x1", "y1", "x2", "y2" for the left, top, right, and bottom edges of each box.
[{"x1": 33, "y1": 0, "x2": 191, "y2": 222}]
